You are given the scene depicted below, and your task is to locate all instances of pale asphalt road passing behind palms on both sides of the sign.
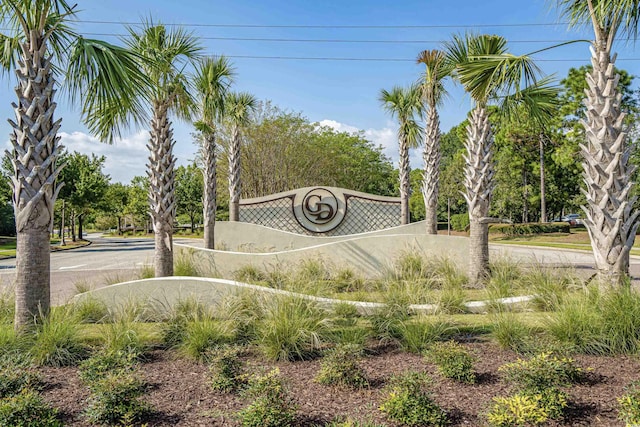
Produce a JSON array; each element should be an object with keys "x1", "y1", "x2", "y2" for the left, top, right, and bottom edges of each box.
[{"x1": 0, "y1": 234, "x2": 640, "y2": 304}]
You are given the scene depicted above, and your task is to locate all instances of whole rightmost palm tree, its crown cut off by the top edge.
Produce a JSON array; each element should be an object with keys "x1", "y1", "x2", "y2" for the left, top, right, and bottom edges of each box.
[{"x1": 556, "y1": 0, "x2": 640, "y2": 285}]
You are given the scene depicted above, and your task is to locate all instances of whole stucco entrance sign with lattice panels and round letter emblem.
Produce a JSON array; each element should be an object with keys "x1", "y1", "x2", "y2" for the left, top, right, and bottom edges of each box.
[{"x1": 240, "y1": 187, "x2": 400, "y2": 236}]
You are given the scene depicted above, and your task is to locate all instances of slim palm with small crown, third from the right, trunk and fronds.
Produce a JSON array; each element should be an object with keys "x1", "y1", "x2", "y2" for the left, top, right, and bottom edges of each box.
[{"x1": 417, "y1": 49, "x2": 452, "y2": 234}]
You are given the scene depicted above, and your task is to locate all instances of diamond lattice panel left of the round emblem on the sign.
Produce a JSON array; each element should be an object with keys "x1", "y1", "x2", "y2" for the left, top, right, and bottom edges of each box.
[{"x1": 239, "y1": 196, "x2": 310, "y2": 234}]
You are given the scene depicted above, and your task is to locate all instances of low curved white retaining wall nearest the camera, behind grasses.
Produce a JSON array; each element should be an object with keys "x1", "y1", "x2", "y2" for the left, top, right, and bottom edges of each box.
[{"x1": 74, "y1": 277, "x2": 532, "y2": 315}]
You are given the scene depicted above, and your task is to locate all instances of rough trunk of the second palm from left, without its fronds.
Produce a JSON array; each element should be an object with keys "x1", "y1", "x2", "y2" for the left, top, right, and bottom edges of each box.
[{"x1": 147, "y1": 101, "x2": 176, "y2": 277}]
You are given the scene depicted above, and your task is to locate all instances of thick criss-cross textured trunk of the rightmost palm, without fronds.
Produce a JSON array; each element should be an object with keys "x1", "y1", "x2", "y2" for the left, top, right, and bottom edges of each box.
[{"x1": 580, "y1": 39, "x2": 639, "y2": 286}]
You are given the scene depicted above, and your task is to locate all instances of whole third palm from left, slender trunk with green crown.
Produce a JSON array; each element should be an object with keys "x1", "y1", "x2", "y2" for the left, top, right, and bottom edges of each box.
[{"x1": 194, "y1": 56, "x2": 235, "y2": 249}]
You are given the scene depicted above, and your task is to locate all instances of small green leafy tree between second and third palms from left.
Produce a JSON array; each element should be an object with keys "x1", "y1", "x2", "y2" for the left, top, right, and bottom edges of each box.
[{"x1": 176, "y1": 164, "x2": 204, "y2": 233}]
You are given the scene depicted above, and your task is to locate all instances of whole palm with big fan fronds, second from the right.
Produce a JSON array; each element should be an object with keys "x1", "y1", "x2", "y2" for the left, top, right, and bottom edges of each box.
[{"x1": 445, "y1": 34, "x2": 555, "y2": 285}]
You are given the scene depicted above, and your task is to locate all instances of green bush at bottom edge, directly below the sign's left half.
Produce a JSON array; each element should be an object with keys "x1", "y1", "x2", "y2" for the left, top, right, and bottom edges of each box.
[{"x1": 238, "y1": 368, "x2": 296, "y2": 427}]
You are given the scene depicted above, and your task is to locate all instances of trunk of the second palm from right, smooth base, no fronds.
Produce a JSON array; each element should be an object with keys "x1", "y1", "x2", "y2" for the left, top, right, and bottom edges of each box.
[{"x1": 464, "y1": 105, "x2": 494, "y2": 286}]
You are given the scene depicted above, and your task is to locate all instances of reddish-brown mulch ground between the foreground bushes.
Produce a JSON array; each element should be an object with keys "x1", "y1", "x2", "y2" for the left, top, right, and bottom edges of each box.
[{"x1": 40, "y1": 342, "x2": 640, "y2": 427}]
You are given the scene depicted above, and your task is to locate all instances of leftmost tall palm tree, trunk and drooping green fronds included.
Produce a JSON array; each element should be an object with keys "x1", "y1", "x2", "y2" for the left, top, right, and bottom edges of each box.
[{"x1": 0, "y1": 0, "x2": 147, "y2": 330}]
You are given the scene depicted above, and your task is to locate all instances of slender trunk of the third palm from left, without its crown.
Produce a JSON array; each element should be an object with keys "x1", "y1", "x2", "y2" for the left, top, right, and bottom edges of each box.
[{"x1": 202, "y1": 134, "x2": 217, "y2": 249}]
